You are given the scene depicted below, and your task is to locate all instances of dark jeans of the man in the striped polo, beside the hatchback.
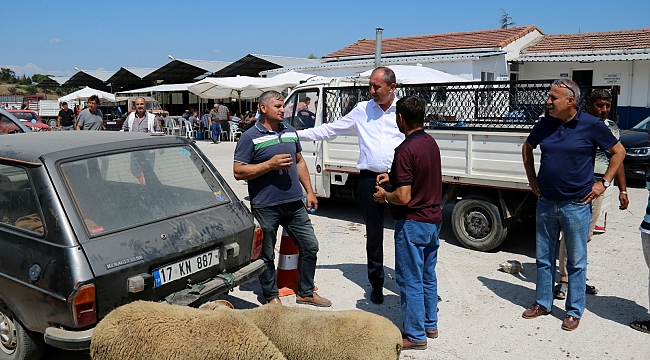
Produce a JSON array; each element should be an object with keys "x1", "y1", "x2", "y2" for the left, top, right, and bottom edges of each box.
[{"x1": 253, "y1": 200, "x2": 318, "y2": 301}]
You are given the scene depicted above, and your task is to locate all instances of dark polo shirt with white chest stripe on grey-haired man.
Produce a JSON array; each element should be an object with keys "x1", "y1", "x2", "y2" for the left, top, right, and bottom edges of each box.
[{"x1": 234, "y1": 121, "x2": 303, "y2": 208}]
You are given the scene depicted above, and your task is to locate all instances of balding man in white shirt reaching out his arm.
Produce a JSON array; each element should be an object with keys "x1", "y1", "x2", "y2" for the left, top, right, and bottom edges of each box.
[{"x1": 298, "y1": 67, "x2": 404, "y2": 304}]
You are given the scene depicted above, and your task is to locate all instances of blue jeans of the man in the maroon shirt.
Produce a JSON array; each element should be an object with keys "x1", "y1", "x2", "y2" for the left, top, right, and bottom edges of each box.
[{"x1": 395, "y1": 220, "x2": 442, "y2": 342}]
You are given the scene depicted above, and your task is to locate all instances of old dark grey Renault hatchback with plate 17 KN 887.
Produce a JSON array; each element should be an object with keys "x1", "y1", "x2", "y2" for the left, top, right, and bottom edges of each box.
[{"x1": 0, "y1": 131, "x2": 264, "y2": 359}]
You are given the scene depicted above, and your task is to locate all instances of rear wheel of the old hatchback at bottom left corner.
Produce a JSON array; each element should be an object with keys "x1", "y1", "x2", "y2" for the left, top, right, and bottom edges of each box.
[{"x1": 0, "y1": 302, "x2": 45, "y2": 360}]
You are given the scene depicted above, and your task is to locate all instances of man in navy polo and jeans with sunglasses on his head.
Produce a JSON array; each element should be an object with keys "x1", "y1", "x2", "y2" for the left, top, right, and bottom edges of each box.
[{"x1": 522, "y1": 79, "x2": 625, "y2": 331}]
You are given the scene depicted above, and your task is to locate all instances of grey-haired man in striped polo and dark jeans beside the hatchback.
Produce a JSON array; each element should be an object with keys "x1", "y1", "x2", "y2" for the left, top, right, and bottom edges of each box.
[{"x1": 233, "y1": 91, "x2": 332, "y2": 307}]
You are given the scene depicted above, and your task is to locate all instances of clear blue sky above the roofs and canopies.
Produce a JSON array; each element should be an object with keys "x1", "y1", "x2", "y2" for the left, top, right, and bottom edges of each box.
[{"x1": 0, "y1": 0, "x2": 650, "y2": 76}]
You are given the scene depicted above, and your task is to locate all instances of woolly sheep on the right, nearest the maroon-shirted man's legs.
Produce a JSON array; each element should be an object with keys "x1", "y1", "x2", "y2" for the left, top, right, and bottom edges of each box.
[{"x1": 205, "y1": 304, "x2": 402, "y2": 360}]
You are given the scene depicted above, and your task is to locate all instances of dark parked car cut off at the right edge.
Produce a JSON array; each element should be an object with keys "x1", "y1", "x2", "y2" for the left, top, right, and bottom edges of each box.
[{"x1": 620, "y1": 116, "x2": 650, "y2": 180}]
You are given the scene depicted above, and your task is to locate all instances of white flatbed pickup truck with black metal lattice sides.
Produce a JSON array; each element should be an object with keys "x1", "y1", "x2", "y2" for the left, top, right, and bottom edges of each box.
[{"x1": 285, "y1": 78, "x2": 617, "y2": 251}]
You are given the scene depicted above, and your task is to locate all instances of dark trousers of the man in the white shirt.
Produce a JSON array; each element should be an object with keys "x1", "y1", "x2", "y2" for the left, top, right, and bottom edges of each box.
[{"x1": 359, "y1": 170, "x2": 385, "y2": 288}]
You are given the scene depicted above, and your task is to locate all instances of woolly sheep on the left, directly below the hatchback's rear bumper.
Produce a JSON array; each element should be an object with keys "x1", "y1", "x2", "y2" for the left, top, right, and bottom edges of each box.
[{"x1": 90, "y1": 301, "x2": 286, "y2": 360}]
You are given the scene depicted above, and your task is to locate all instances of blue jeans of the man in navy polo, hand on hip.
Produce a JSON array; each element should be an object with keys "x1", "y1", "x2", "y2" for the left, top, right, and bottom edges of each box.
[{"x1": 535, "y1": 198, "x2": 591, "y2": 318}]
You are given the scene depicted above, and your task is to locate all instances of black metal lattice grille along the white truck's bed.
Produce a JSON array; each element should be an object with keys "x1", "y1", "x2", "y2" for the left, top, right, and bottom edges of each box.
[{"x1": 324, "y1": 80, "x2": 618, "y2": 130}]
